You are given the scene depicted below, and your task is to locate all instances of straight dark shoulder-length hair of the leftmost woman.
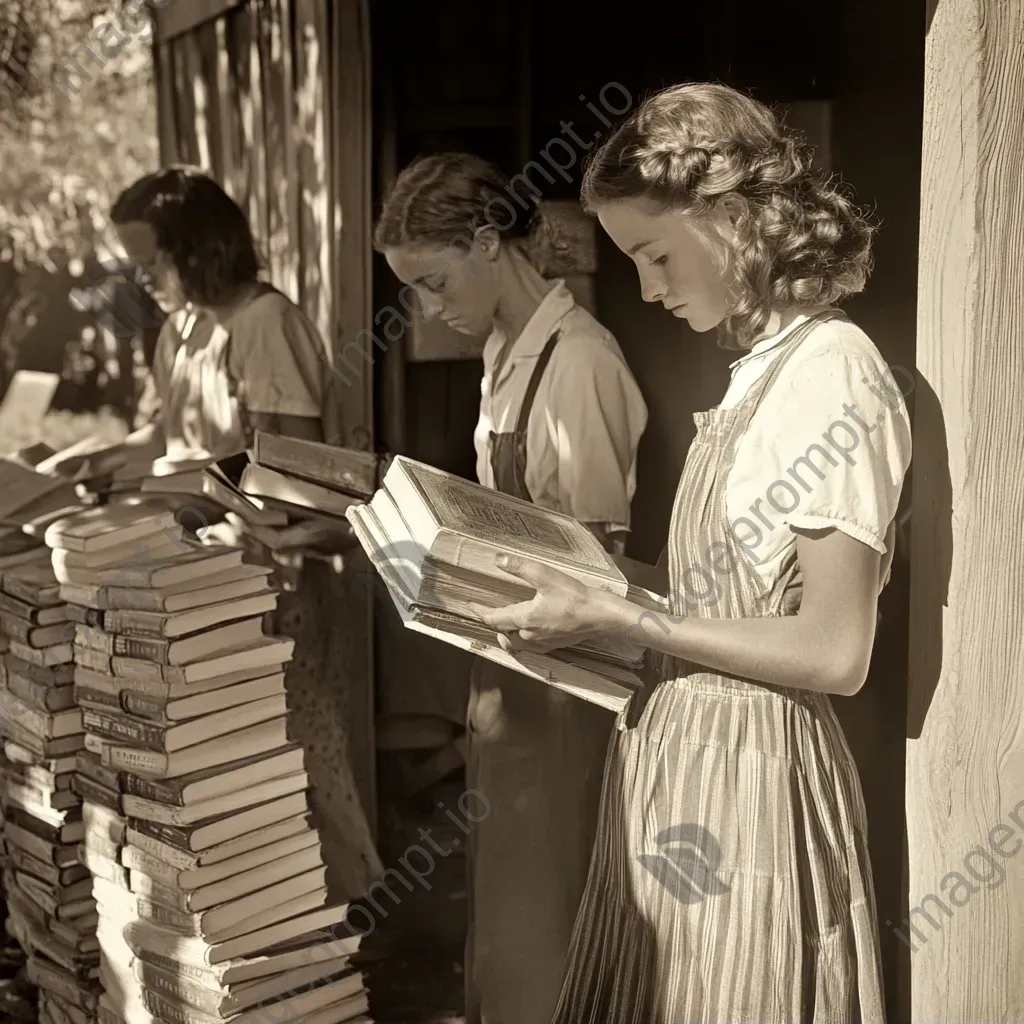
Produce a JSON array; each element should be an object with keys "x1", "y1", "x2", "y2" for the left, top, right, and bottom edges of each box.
[{"x1": 111, "y1": 166, "x2": 260, "y2": 306}]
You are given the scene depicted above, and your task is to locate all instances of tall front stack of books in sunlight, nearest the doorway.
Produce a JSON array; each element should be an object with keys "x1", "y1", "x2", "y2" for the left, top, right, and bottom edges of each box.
[{"x1": 46, "y1": 506, "x2": 368, "y2": 1024}]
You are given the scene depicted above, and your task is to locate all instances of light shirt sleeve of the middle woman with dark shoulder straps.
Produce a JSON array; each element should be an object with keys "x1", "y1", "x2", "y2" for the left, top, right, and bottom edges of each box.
[{"x1": 545, "y1": 338, "x2": 647, "y2": 529}]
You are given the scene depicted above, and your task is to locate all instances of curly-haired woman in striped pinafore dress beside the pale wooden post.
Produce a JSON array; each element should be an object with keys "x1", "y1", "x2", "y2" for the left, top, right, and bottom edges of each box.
[{"x1": 485, "y1": 84, "x2": 912, "y2": 1024}]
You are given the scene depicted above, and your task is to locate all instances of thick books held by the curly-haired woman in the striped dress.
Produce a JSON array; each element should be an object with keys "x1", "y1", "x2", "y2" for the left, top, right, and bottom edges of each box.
[{"x1": 346, "y1": 456, "x2": 664, "y2": 711}]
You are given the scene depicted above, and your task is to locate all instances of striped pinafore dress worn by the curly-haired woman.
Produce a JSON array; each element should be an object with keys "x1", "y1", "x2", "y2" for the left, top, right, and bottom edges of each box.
[{"x1": 553, "y1": 311, "x2": 885, "y2": 1024}]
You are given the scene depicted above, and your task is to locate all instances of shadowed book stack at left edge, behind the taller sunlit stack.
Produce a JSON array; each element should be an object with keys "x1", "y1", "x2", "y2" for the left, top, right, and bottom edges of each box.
[{"x1": 0, "y1": 560, "x2": 99, "y2": 1021}]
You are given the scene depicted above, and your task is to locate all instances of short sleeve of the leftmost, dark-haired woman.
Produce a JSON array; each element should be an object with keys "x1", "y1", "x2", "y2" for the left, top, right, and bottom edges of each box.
[{"x1": 229, "y1": 295, "x2": 327, "y2": 419}]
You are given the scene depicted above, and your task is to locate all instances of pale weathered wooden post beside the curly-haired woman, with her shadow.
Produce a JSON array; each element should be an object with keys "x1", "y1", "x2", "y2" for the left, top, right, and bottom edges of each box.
[{"x1": 905, "y1": 0, "x2": 1024, "y2": 1024}]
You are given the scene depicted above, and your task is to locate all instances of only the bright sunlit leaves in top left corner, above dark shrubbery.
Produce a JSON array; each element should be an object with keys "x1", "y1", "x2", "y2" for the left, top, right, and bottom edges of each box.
[{"x1": 0, "y1": 0, "x2": 159, "y2": 269}]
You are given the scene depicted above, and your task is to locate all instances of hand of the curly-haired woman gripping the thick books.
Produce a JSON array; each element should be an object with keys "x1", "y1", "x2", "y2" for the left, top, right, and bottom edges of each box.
[{"x1": 476, "y1": 555, "x2": 623, "y2": 652}]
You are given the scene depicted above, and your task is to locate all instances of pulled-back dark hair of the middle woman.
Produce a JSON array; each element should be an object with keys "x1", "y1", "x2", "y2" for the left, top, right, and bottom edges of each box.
[{"x1": 374, "y1": 153, "x2": 541, "y2": 251}]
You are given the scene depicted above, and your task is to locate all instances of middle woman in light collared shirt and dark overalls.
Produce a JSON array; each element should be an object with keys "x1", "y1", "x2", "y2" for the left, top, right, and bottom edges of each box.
[{"x1": 375, "y1": 154, "x2": 647, "y2": 1024}]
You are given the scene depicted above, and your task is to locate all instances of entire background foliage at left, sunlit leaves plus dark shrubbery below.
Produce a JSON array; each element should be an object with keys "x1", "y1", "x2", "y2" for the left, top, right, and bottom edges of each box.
[{"x1": 0, "y1": 0, "x2": 159, "y2": 417}]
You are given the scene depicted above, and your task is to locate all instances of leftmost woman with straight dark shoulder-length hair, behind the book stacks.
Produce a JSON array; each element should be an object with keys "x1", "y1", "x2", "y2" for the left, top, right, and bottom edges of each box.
[{"x1": 50, "y1": 167, "x2": 381, "y2": 899}]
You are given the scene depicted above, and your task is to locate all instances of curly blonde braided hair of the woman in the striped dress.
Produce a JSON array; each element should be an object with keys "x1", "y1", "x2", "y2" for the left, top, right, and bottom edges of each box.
[{"x1": 582, "y1": 83, "x2": 876, "y2": 348}]
